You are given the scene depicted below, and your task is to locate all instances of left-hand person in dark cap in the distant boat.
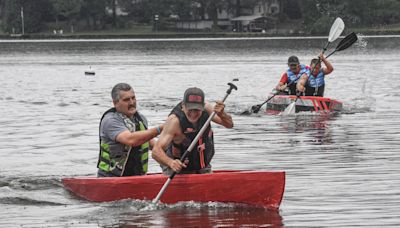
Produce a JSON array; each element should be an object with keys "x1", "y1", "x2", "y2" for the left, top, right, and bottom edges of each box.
[{"x1": 276, "y1": 55, "x2": 309, "y2": 95}]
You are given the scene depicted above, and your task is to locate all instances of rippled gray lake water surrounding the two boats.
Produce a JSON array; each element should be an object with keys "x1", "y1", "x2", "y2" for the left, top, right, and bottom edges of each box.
[{"x1": 0, "y1": 36, "x2": 400, "y2": 227}]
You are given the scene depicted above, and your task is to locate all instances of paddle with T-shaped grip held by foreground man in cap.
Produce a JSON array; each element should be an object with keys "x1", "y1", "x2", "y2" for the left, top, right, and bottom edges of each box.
[{"x1": 153, "y1": 82, "x2": 237, "y2": 203}]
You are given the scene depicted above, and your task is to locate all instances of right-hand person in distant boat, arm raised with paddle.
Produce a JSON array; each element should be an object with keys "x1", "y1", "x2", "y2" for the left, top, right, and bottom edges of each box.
[{"x1": 297, "y1": 53, "x2": 333, "y2": 97}]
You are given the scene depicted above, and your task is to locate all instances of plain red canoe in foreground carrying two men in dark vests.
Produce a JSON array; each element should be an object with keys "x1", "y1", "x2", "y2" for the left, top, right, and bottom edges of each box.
[{"x1": 62, "y1": 171, "x2": 285, "y2": 210}]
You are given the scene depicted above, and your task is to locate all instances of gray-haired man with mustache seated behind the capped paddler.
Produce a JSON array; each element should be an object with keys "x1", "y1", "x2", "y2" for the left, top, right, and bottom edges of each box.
[{"x1": 97, "y1": 83, "x2": 163, "y2": 177}]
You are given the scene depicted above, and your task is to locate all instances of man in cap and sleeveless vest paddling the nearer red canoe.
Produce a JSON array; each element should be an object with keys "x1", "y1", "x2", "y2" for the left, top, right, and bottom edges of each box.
[{"x1": 152, "y1": 87, "x2": 233, "y2": 175}]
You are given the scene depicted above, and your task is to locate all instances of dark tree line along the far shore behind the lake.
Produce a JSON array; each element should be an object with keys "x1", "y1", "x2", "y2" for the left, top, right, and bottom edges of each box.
[{"x1": 0, "y1": 0, "x2": 400, "y2": 34}]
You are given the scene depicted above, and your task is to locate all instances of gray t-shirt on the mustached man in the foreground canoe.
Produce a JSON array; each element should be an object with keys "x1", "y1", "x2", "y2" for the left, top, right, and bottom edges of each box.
[{"x1": 100, "y1": 112, "x2": 148, "y2": 156}]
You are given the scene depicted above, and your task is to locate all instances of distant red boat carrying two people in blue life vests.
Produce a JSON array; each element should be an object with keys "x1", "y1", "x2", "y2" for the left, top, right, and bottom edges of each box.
[{"x1": 266, "y1": 95, "x2": 343, "y2": 114}]
